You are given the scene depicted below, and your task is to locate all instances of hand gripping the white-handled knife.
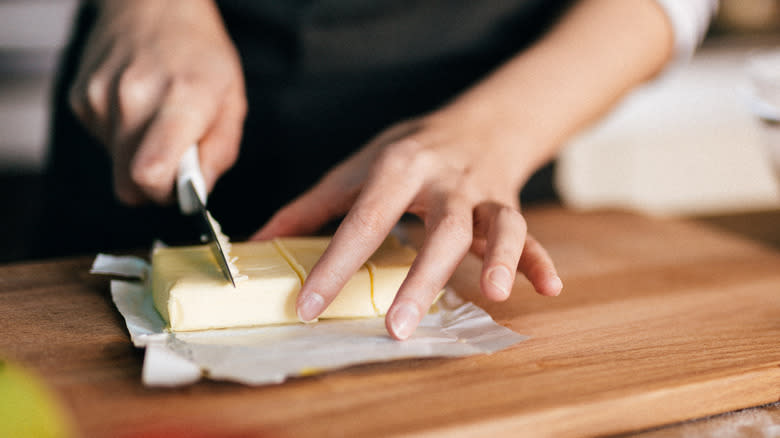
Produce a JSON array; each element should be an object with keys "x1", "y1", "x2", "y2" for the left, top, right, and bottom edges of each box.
[{"x1": 69, "y1": 0, "x2": 247, "y2": 205}]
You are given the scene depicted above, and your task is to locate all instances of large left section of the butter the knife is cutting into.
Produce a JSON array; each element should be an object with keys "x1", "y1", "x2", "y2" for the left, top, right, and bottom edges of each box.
[{"x1": 152, "y1": 242, "x2": 301, "y2": 331}]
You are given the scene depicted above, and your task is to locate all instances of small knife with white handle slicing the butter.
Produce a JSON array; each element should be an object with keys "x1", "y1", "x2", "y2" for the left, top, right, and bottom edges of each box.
[{"x1": 176, "y1": 144, "x2": 236, "y2": 287}]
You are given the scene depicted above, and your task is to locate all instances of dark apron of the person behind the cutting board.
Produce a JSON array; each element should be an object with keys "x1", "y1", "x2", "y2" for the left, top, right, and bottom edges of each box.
[{"x1": 34, "y1": 0, "x2": 567, "y2": 257}]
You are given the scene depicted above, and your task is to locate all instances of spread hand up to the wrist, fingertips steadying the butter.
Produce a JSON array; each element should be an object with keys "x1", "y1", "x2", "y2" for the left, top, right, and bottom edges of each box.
[{"x1": 253, "y1": 106, "x2": 562, "y2": 339}]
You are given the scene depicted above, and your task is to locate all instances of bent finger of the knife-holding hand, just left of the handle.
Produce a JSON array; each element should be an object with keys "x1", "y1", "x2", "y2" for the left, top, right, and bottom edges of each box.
[{"x1": 126, "y1": 80, "x2": 219, "y2": 204}]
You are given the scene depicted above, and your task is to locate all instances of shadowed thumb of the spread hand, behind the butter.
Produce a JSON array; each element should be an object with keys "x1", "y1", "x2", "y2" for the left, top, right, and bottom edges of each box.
[{"x1": 251, "y1": 160, "x2": 360, "y2": 240}]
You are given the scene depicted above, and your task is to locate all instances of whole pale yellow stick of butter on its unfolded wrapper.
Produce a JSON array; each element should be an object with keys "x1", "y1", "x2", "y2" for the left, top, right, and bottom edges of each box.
[{"x1": 152, "y1": 237, "x2": 416, "y2": 331}]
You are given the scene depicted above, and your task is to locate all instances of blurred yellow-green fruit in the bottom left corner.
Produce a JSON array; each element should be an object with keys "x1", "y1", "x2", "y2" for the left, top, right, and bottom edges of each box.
[{"x1": 0, "y1": 359, "x2": 73, "y2": 438}]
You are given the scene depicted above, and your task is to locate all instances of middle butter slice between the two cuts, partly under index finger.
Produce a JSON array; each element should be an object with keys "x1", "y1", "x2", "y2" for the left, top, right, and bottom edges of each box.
[{"x1": 274, "y1": 237, "x2": 377, "y2": 318}]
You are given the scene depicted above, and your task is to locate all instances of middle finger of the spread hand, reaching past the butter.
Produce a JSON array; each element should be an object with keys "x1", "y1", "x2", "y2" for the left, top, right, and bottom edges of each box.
[{"x1": 385, "y1": 193, "x2": 472, "y2": 340}]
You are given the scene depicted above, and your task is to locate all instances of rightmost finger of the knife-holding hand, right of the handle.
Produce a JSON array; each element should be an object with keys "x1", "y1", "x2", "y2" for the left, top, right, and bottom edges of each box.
[{"x1": 199, "y1": 84, "x2": 247, "y2": 192}]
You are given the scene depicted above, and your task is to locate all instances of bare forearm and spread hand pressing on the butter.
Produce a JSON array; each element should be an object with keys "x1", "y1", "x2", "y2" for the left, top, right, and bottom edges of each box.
[{"x1": 254, "y1": 0, "x2": 674, "y2": 339}]
